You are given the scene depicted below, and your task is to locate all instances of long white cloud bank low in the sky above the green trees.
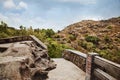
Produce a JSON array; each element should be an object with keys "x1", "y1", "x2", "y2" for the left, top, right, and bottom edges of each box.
[{"x1": 0, "y1": 13, "x2": 63, "y2": 31}]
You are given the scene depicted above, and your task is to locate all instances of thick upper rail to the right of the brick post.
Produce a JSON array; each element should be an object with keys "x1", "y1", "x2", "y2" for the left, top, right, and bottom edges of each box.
[{"x1": 94, "y1": 56, "x2": 120, "y2": 79}]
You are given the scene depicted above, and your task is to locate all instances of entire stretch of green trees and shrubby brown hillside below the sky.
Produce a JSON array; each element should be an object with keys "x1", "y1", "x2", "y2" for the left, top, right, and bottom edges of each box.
[{"x1": 0, "y1": 18, "x2": 120, "y2": 64}]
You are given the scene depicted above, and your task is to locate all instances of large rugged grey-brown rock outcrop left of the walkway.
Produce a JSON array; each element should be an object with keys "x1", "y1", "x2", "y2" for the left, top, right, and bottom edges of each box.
[{"x1": 0, "y1": 36, "x2": 56, "y2": 80}]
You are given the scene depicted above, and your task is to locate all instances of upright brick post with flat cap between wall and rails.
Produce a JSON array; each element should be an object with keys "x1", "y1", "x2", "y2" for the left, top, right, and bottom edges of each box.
[{"x1": 85, "y1": 53, "x2": 98, "y2": 80}]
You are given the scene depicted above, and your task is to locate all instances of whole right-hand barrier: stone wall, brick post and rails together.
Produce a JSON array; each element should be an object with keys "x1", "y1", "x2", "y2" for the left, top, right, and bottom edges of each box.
[{"x1": 63, "y1": 49, "x2": 120, "y2": 80}]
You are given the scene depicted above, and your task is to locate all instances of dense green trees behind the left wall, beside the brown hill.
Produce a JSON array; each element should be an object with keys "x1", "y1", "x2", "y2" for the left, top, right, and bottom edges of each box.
[{"x1": 0, "y1": 21, "x2": 69, "y2": 58}]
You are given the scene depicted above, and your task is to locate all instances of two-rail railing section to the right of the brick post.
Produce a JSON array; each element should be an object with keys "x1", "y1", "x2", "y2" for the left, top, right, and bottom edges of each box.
[{"x1": 93, "y1": 56, "x2": 120, "y2": 80}]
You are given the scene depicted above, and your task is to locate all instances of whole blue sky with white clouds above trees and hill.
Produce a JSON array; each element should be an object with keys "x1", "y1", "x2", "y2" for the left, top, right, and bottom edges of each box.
[{"x1": 0, "y1": 0, "x2": 120, "y2": 31}]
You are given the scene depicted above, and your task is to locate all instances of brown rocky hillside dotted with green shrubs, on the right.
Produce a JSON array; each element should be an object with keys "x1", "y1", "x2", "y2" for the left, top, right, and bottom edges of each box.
[{"x1": 54, "y1": 17, "x2": 120, "y2": 63}]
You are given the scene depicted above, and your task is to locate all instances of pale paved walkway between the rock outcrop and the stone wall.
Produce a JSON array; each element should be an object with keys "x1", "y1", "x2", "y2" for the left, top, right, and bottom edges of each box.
[{"x1": 47, "y1": 58, "x2": 85, "y2": 80}]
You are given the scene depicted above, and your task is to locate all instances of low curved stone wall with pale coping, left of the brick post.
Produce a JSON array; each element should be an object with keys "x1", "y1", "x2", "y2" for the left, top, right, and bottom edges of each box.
[{"x1": 62, "y1": 49, "x2": 87, "y2": 71}]
